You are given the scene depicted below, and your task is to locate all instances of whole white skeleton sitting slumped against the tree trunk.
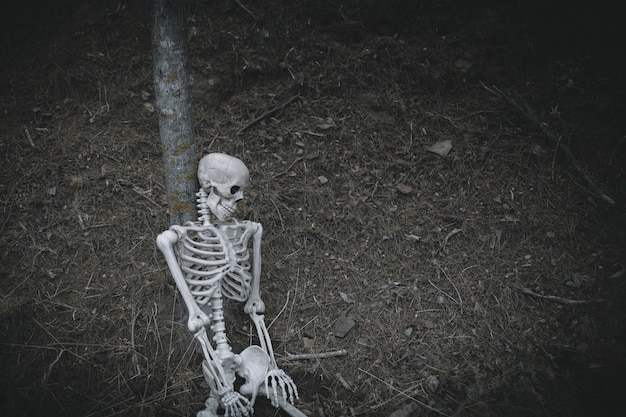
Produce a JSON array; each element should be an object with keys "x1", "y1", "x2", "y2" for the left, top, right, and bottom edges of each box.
[{"x1": 157, "y1": 153, "x2": 305, "y2": 417}]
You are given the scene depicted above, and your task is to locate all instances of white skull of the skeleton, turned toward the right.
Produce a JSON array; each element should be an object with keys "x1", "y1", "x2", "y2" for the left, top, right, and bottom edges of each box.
[{"x1": 198, "y1": 153, "x2": 250, "y2": 221}]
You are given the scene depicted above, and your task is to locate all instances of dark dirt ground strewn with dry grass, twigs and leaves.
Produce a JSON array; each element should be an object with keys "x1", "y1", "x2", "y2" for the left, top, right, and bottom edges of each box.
[{"x1": 0, "y1": 0, "x2": 626, "y2": 417}]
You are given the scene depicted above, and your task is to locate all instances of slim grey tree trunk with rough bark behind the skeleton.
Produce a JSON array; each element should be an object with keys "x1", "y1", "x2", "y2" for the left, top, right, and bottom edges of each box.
[{"x1": 152, "y1": 0, "x2": 199, "y2": 225}]
